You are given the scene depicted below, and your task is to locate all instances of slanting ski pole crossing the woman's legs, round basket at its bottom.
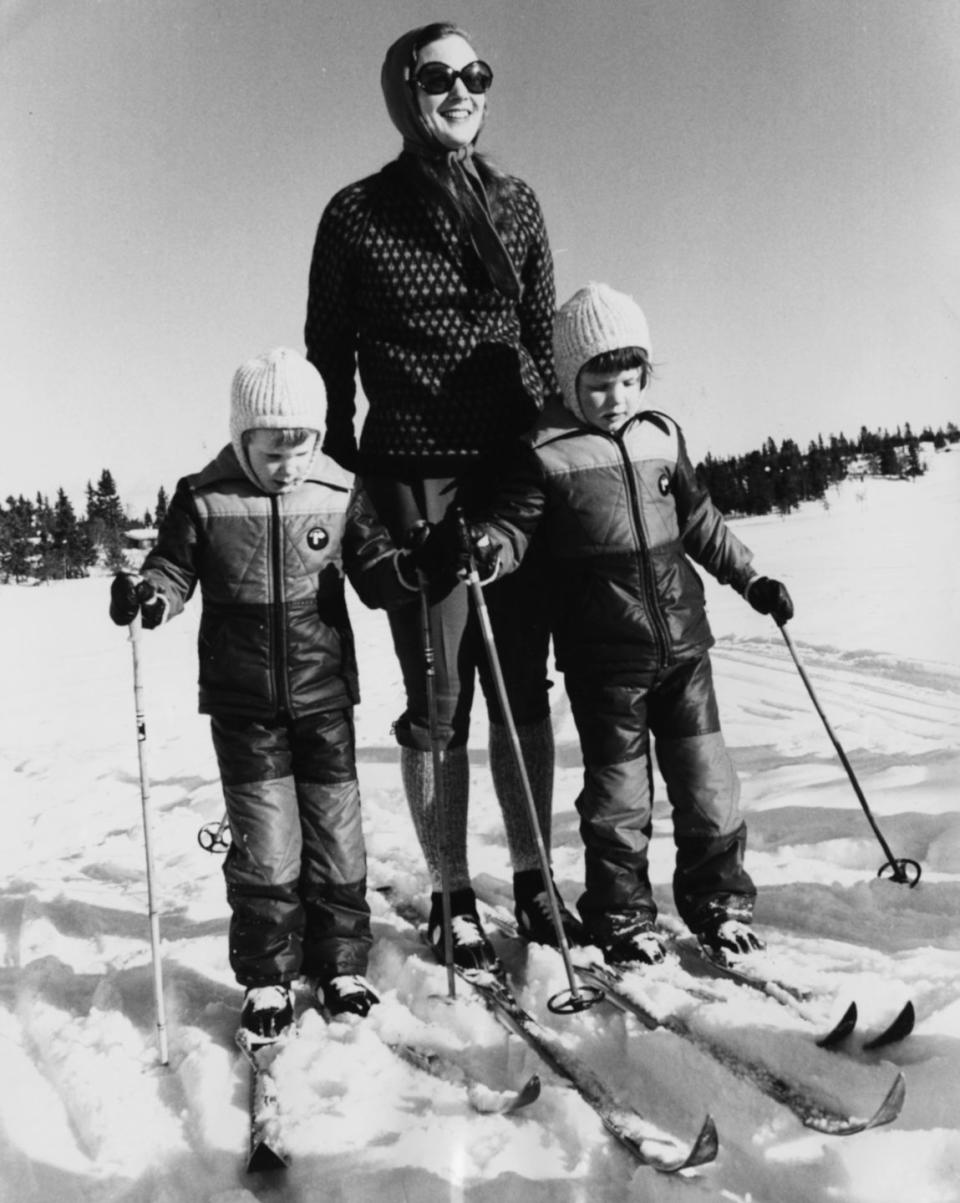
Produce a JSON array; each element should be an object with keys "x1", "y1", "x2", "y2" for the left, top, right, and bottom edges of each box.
[{"x1": 457, "y1": 510, "x2": 604, "y2": 1015}]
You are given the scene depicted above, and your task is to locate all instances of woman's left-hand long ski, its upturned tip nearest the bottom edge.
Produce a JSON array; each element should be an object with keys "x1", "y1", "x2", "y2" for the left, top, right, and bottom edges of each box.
[{"x1": 457, "y1": 968, "x2": 718, "y2": 1174}]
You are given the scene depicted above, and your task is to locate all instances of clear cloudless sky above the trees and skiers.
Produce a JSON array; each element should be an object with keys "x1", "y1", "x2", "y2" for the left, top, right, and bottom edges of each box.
[{"x1": 0, "y1": 0, "x2": 960, "y2": 509}]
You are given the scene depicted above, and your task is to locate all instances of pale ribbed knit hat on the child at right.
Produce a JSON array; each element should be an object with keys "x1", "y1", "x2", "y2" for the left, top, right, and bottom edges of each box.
[{"x1": 553, "y1": 284, "x2": 651, "y2": 420}]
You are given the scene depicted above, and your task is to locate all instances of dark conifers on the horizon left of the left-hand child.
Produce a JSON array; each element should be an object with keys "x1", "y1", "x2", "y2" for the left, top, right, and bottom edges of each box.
[{"x1": 0, "y1": 468, "x2": 167, "y2": 582}]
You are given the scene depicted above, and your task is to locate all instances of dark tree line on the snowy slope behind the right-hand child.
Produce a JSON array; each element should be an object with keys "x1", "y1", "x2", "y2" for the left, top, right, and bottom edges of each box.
[{"x1": 697, "y1": 422, "x2": 960, "y2": 515}]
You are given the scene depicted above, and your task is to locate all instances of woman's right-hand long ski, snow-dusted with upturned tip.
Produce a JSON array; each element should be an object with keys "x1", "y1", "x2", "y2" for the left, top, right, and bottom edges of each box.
[{"x1": 575, "y1": 965, "x2": 906, "y2": 1136}]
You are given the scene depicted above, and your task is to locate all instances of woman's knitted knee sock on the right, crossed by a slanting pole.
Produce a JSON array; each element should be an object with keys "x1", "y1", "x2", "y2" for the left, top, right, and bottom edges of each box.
[{"x1": 490, "y1": 718, "x2": 553, "y2": 873}]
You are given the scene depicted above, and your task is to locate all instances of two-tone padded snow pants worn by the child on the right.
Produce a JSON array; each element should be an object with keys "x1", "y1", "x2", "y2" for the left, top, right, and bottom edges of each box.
[{"x1": 567, "y1": 656, "x2": 757, "y2": 941}]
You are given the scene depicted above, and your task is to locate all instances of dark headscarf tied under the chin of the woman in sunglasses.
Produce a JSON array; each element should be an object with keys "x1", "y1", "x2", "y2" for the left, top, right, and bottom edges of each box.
[{"x1": 380, "y1": 25, "x2": 521, "y2": 301}]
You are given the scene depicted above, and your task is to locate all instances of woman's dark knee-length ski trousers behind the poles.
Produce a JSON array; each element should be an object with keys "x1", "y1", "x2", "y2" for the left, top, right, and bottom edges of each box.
[{"x1": 363, "y1": 476, "x2": 550, "y2": 752}]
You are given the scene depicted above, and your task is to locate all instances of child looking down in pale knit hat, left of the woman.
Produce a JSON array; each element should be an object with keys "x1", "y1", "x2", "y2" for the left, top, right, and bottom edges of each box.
[{"x1": 109, "y1": 348, "x2": 415, "y2": 1041}]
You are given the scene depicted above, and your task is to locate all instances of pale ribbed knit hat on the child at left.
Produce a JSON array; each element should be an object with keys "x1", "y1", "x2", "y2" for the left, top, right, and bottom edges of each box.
[{"x1": 230, "y1": 346, "x2": 326, "y2": 474}]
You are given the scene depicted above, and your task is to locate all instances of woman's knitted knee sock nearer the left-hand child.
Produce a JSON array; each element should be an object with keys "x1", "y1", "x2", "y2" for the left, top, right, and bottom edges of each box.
[{"x1": 401, "y1": 747, "x2": 470, "y2": 890}]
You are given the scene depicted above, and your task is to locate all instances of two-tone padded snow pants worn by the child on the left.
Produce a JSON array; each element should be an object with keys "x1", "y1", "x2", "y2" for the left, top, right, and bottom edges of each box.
[{"x1": 211, "y1": 709, "x2": 372, "y2": 986}]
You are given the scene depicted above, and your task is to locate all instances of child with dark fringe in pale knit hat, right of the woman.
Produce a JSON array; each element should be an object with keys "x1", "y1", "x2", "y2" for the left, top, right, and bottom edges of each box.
[{"x1": 421, "y1": 284, "x2": 793, "y2": 964}]
